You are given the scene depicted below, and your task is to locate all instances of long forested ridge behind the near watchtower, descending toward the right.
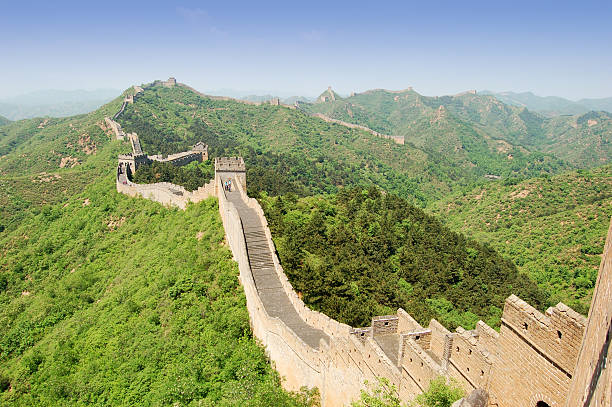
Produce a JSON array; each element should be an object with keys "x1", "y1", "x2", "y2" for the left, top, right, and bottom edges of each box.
[{"x1": 118, "y1": 87, "x2": 566, "y2": 206}]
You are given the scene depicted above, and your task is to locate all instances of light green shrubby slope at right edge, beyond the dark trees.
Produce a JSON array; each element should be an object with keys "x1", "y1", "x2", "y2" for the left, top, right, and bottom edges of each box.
[{"x1": 432, "y1": 166, "x2": 612, "y2": 314}]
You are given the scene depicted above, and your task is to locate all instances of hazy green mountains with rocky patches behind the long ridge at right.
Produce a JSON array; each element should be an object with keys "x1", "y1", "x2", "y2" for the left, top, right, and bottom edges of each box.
[{"x1": 301, "y1": 89, "x2": 612, "y2": 169}]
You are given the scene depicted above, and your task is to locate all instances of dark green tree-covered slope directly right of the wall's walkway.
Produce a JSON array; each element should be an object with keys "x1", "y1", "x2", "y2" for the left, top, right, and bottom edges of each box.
[{"x1": 261, "y1": 188, "x2": 546, "y2": 329}]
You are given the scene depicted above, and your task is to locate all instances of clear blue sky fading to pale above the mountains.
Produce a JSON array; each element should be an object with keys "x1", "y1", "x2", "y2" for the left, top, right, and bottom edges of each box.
[{"x1": 0, "y1": 0, "x2": 612, "y2": 99}]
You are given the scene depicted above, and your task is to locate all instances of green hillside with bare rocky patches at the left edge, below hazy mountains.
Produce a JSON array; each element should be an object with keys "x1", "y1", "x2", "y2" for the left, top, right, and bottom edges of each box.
[{"x1": 0, "y1": 93, "x2": 127, "y2": 230}]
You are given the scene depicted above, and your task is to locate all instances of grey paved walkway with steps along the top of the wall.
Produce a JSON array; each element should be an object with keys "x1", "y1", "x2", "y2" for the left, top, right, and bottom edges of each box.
[{"x1": 221, "y1": 178, "x2": 329, "y2": 349}]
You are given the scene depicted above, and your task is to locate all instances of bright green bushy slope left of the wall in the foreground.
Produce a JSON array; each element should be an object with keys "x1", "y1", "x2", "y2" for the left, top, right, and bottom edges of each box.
[{"x1": 0, "y1": 177, "x2": 316, "y2": 406}]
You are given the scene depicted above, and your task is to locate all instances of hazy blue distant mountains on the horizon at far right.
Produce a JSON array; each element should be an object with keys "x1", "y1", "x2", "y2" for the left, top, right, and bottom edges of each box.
[{"x1": 478, "y1": 90, "x2": 612, "y2": 116}]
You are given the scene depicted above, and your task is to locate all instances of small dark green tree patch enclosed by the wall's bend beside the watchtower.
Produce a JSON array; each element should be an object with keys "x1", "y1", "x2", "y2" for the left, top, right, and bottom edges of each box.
[{"x1": 132, "y1": 160, "x2": 215, "y2": 191}]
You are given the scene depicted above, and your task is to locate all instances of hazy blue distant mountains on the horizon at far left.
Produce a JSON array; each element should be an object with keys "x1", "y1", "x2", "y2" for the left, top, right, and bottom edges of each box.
[{"x1": 0, "y1": 89, "x2": 121, "y2": 120}]
